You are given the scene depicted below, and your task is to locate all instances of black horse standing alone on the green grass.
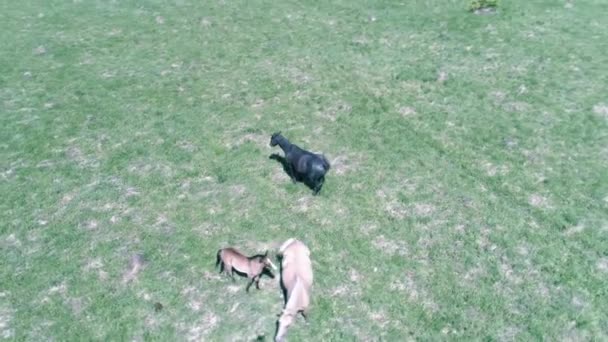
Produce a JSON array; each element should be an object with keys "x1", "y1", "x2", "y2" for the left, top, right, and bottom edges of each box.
[{"x1": 270, "y1": 132, "x2": 331, "y2": 195}]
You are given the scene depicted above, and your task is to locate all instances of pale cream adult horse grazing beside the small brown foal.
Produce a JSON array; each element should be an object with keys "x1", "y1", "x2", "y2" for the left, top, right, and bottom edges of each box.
[{"x1": 275, "y1": 238, "x2": 313, "y2": 342}]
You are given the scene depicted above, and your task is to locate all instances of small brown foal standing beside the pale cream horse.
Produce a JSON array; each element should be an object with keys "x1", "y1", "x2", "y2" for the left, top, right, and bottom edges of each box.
[{"x1": 215, "y1": 247, "x2": 277, "y2": 292}]
